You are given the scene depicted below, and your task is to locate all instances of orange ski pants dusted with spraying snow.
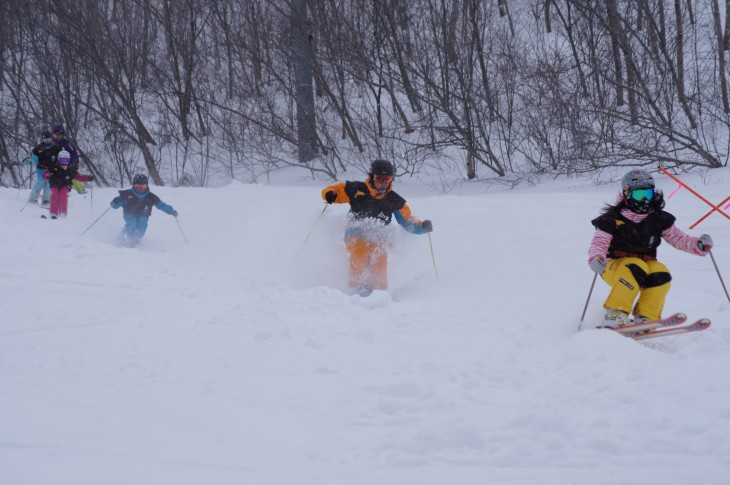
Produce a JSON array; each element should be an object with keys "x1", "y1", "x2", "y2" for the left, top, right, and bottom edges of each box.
[{"x1": 345, "y1": 237, "x2": 388, "y2": 290}]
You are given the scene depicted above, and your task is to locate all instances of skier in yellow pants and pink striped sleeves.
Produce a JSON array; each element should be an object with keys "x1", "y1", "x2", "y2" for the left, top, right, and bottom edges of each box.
[{"x1": 588, "y1": 170, "x2": 713, "y2": 327}]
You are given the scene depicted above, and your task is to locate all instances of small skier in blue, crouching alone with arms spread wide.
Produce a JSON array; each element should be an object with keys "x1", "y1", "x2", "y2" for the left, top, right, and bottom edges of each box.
[{"x1": 109, "y1": 174, "x2": 177, "y2": 248}]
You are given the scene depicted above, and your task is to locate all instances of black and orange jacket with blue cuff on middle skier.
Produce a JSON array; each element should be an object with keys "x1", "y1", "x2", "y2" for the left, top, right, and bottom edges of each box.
[{"x1": 322, "y1": 179, "x2": 426, "y2": 237}]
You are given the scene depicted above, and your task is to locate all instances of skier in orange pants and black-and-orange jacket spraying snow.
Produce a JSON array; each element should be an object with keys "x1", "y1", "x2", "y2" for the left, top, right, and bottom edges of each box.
[{"x1": 322, "y1": 160, "x2": 433, "y2": 296}]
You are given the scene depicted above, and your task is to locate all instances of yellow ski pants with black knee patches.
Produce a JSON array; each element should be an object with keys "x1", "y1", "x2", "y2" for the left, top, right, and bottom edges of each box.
[{"x1": 601, "y1": 258, "x2": 672, "y2": 320}]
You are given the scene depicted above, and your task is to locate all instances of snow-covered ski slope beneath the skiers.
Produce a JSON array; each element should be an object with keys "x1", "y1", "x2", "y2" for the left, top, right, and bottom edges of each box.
[{"x1": 0, "y1": 170, "x2": 730, "y2": 485}]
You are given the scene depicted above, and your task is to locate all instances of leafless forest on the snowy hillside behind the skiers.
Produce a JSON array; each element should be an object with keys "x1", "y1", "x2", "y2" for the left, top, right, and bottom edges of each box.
[{"x1": 0, "y1": 0, "x2": 730, "y2": 187}]
